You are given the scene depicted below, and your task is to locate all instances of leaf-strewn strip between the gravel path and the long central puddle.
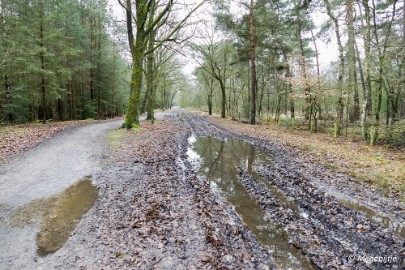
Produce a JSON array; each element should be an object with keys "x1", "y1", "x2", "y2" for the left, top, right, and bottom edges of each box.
[{"x1": 60, "y1": 116, "x2": 270, "y2": 269}]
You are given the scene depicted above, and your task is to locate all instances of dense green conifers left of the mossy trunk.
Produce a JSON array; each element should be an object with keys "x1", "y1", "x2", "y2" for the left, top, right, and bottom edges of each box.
[{"x1": 0, "y1": 0, "x2": 130, "y2": 123}]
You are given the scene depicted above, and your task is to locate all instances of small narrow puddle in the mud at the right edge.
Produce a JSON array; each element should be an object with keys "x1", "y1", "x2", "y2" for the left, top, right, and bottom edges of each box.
[{"x1": 339, "y1": 199, "x2": 405, "y2": 239}]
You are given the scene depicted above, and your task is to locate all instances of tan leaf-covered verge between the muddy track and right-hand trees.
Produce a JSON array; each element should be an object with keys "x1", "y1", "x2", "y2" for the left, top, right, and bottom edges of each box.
[{"x1": 210, "y1": 116, "x2": 405, "y2": 201}]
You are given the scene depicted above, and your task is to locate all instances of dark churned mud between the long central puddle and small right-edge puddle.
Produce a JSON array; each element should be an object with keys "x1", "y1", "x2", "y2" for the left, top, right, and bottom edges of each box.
[{"x1": 240, "y1": 168, "x2": 403, "y2": 269}]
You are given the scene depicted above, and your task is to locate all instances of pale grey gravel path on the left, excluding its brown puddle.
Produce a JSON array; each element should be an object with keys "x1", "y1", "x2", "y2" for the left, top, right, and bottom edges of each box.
[{"x1": 0, "y1": 120, "x2": 122, "y2": 269}]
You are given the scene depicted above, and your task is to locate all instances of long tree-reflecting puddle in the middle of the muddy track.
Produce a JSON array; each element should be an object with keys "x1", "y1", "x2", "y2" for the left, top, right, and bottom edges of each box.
[{"x1": 187, "y1": 137, "x2": 314, "y2": 269}]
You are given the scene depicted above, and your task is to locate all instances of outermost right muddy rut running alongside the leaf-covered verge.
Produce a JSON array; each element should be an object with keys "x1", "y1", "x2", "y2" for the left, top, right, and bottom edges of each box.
[{"x1": 183, "y1": 110, "x2": 405, "y2": 220}]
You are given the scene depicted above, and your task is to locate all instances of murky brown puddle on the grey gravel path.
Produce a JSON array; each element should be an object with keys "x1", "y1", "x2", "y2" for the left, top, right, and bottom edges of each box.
[{"x1": 10, "y1": 177, "x2": 98, "y2": 256}]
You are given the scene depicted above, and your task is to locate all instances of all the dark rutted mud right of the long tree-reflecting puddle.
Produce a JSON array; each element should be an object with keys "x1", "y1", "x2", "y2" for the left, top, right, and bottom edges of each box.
[{"x1": 185, "y1": 110, "x2": 405, "y2": 269}]
